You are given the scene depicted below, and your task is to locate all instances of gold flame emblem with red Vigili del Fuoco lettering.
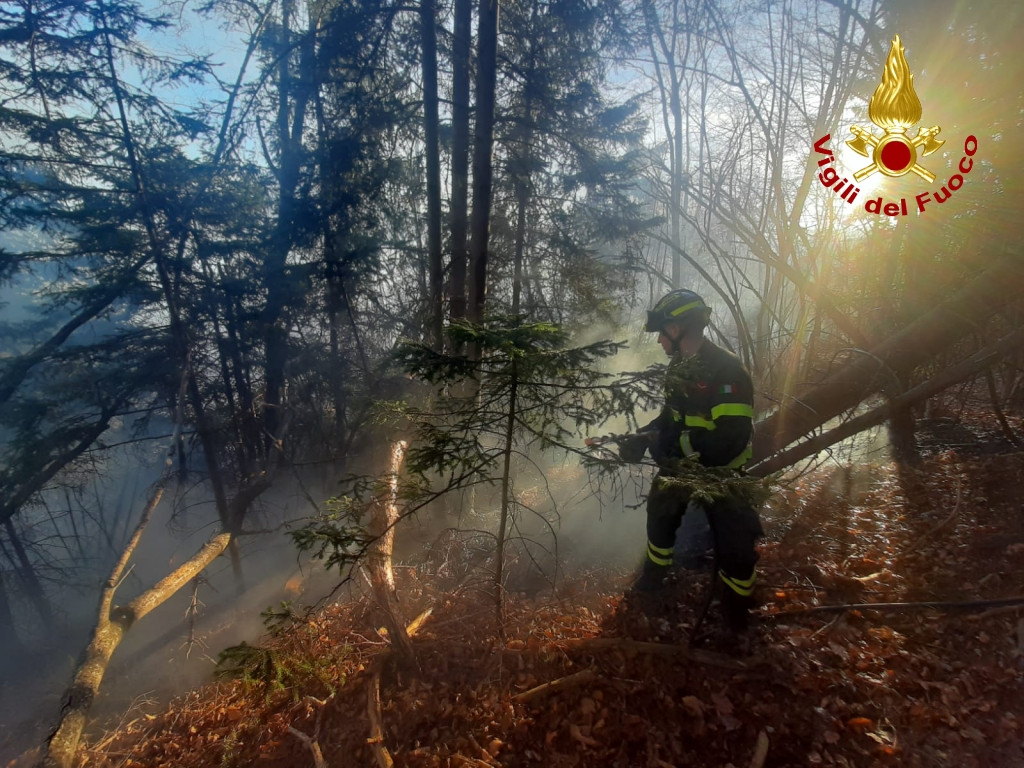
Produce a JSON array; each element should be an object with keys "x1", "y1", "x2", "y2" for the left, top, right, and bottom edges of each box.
[{"x1": 814, "y1": 35, "x2": 978, "y2": 216}]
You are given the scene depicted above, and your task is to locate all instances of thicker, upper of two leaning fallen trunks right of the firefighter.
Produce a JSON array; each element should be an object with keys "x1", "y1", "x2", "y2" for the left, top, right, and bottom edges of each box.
[{"x1": 754, "y1": 257, "x2": 1024, "y2": 462}]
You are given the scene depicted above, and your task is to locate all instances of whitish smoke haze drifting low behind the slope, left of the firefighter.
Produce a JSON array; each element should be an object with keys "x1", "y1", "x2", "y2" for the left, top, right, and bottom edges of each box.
[{"x1": 0, "y1": 317, "x2": 679, "y2": 763}]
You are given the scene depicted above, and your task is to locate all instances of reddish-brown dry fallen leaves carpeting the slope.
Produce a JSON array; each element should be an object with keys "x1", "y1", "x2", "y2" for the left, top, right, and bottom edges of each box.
[{"x1": 75, "y1": 460, "x2": 1024, "y2": 768}]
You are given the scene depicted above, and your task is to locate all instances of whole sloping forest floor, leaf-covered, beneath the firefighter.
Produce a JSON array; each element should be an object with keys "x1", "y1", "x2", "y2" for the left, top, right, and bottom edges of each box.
[{"x1": 24, "y1": 424, "x2": 1024, "y2": 768}]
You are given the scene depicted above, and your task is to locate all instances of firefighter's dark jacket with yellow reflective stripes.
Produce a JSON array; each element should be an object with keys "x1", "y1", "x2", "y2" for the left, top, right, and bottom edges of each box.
[{"x1": 640, "y1": 339, "x2": 754, "y2": 469}]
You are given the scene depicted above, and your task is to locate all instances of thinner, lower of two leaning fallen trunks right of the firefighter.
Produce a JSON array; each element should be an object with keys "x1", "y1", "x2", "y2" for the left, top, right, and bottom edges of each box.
[{"x1": 750, "y1": 328, "x2": 1024, "y2": 477}]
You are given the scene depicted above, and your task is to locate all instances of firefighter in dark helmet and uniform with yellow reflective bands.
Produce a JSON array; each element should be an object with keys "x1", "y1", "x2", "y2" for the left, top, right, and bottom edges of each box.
[{"x1": 620, "y1": 290, "x2": 763, "y2": 631}]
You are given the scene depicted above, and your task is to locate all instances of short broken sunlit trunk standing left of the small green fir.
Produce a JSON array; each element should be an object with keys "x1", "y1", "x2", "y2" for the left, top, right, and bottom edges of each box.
[{"x1": 367, "y1": 440, "x2": 414, "y2": 662}]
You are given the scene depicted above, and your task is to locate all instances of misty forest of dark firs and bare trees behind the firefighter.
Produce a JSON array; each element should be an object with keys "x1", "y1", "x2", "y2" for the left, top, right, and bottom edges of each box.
[{"x1": 0, "y1": 0, "x2": 1024, "y2": 768}]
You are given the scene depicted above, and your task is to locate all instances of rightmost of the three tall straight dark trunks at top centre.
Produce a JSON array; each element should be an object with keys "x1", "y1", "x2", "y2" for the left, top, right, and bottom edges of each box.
[{"x1": 468, "y1": 0, "x2": 498, "y2": 323}]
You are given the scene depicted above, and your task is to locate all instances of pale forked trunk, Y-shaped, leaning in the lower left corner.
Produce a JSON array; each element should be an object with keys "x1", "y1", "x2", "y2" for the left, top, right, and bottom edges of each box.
[{"x1": 37, "y1": 481, "x2": 231, "y2": 768}]
